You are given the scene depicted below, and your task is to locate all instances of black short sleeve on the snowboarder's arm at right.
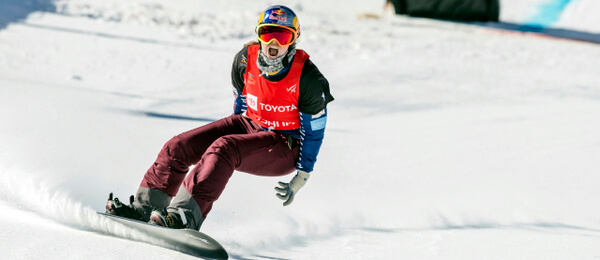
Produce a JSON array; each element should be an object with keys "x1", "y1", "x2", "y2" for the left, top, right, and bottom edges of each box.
[{"x1": 298, "y1": 59, "x2": 334, "y2": 115}]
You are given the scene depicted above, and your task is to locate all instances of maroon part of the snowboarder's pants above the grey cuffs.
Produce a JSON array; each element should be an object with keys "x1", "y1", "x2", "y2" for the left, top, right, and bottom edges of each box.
[{"x1": 141, "y1": 115, "x2": 299, "y2": 218}]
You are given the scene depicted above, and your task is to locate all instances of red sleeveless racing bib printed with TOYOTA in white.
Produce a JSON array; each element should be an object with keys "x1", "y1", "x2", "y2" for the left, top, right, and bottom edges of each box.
[{"x1": 243, "y1": 44, "x2": 309, "y2": 130}]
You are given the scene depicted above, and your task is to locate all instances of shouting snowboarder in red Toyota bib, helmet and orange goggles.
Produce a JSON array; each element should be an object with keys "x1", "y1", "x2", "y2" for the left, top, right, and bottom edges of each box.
[{"x1": 106, "y1": 5, "x2": 333, "y2": 230}]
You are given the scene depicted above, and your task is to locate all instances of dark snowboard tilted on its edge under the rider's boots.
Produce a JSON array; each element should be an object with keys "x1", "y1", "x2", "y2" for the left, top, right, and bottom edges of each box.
[{"x1": 98, "y1": 212, "x2": 229, "y2": 259}]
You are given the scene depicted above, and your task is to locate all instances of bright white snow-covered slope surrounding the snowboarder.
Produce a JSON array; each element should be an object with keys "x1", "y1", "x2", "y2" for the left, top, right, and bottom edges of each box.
[{"x1": 0, "y1": 0, "x2": 600, "y2": 259}]
